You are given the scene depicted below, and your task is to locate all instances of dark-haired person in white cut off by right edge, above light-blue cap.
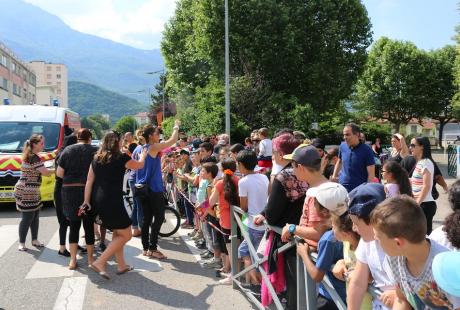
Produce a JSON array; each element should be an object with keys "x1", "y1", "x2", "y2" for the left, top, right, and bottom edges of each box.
[{"x1": 430, "y1": 180, "x2": 460, "y2": 251}]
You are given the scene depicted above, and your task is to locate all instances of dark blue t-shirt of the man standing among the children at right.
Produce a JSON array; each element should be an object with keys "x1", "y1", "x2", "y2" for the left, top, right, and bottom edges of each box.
[{"x1": 339, "y1": 142, "x2": 375, "y2": 192}]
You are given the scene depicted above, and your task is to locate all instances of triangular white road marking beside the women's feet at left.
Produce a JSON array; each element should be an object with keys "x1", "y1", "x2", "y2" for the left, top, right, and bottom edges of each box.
[{"x1": 26, "y1": 230, "x2": 74, "y2": 279}]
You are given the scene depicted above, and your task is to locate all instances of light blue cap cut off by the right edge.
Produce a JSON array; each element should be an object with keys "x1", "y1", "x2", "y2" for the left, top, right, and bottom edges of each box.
[{"x1": 431, "y1": 251, "x2": 460, "y2": 297}]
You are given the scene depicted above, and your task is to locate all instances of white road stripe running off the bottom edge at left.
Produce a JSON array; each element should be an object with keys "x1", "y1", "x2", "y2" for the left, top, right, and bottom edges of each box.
[{"x1": 53, "y1": 277, "x2": 88, "y2": 310}]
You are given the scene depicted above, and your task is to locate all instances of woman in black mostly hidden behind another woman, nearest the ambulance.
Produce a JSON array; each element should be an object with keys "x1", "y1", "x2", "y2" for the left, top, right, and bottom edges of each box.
[{"x1": 54, "y1": 134, "x2": 78, "y2": 257}]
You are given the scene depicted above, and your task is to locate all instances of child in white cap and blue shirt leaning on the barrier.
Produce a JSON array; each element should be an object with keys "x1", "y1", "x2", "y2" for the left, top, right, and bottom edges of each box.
[{"x1": 297, "y1": 182, "x2": 348, "y2": 309}]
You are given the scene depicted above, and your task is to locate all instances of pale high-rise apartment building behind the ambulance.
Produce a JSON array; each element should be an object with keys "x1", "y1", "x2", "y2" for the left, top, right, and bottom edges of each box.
[{"x1": 29, "y1": 61, "x2": 69, "y2": 108}]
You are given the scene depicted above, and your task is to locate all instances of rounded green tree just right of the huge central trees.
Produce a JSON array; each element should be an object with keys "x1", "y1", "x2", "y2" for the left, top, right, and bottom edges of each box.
[{"x1": 355, "y1": 37, "x2": 430, "y2": 131}]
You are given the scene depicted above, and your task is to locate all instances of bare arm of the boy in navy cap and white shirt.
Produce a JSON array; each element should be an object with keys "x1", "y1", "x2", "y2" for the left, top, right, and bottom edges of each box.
[{"x1": 347, "y1": 261, "x2": 370, "y2": 310}]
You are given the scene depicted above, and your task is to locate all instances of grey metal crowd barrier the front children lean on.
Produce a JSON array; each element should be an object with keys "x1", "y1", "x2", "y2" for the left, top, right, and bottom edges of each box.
[{"x1": 230, "y1": 206, "x2": 381, "y2": 310}]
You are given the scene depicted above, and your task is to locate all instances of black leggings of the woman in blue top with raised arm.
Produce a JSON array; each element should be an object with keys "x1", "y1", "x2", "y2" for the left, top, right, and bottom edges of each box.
[{"x1": 140, "y1": 191, "x2": 165, "y2": 251}]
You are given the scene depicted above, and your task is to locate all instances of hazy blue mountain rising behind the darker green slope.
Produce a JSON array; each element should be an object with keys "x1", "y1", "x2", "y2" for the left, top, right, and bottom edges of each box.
[{"x1": 0, "y1": 0, "x2": 164, "y2": 117}]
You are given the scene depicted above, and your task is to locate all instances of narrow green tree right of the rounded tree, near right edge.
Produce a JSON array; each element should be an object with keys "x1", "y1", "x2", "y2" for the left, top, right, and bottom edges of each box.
[{"x1": 423, "y1": 45, "x2": 456, "y2": 147}]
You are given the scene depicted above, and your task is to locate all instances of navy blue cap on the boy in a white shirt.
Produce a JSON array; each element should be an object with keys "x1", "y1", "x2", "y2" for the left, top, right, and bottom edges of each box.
[{"x1": 348, "y1": 183, "x2": 386, "y2": 218}]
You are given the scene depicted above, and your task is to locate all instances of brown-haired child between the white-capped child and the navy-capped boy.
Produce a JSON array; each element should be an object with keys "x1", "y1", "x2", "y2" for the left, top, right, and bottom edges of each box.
[{"x1": 332, "y1": 213, "x2": 372, "y2": 310}]
